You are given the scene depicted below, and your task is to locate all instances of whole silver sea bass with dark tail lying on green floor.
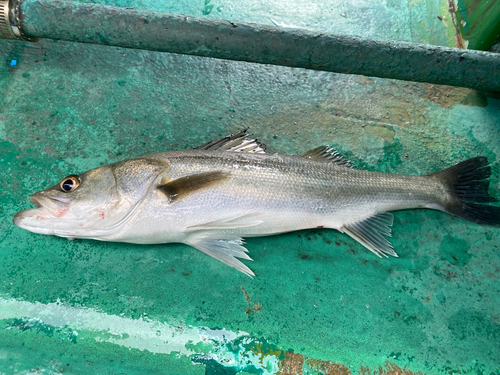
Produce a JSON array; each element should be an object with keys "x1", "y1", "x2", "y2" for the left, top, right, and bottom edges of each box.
[{"x1": 14, "y1": 130, "x2": 500, "y2": 276}]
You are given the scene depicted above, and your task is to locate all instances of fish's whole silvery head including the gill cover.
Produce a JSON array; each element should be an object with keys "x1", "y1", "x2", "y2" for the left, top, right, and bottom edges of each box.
[{"x1": 14, "y1": 158, "x2": 169, "y2": 240}]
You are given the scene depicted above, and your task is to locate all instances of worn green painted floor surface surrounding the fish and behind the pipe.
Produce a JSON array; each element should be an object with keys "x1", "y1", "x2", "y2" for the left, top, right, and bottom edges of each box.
[{"x1": 0, "y1": 0, "x2": 500, "y2": 375}]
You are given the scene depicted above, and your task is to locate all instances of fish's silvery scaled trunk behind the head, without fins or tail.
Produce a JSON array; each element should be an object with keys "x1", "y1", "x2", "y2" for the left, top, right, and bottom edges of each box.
[{"x1": 106, "y1": 150, "x2": 438, "y2": 243}]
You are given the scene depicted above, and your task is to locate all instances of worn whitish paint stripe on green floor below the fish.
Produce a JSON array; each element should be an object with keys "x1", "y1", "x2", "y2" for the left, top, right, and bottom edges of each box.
[{"x1": 0, "y1": 298, "x2": 246, "y2": 355}]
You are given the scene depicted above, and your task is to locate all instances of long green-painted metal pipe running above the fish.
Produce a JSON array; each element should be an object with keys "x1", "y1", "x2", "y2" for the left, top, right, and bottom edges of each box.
[{"x1": 0, "y1": 0, "x2": 500, "y2": 91}]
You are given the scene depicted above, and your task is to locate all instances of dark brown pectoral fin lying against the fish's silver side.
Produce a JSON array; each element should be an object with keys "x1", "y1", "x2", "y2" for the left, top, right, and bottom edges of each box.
[{"x1": 158, "y1": 171, "x2": 229, "y2": 203}]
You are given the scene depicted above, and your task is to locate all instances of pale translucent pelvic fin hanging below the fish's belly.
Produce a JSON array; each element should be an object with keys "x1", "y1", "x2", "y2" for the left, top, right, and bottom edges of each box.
[{"x1": 188, "y1": 236, "x2": 255, "y2": 277}]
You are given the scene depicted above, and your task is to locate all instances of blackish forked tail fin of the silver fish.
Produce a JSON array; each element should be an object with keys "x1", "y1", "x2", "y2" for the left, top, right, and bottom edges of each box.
[{"x1": 430, "y1": 156, "x2": 500, "y2": 227}]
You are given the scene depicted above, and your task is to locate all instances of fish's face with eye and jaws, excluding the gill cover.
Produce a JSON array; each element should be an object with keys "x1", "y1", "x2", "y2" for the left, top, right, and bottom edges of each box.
[{"x1": 13, "y1": 166, "x2": 119, "y2": 238}]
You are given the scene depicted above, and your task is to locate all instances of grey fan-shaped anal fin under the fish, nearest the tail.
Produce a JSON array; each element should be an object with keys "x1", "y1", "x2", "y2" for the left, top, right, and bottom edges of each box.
[{"x1": 340, "y1": 212, "x2": 398, "y2": 257}]
